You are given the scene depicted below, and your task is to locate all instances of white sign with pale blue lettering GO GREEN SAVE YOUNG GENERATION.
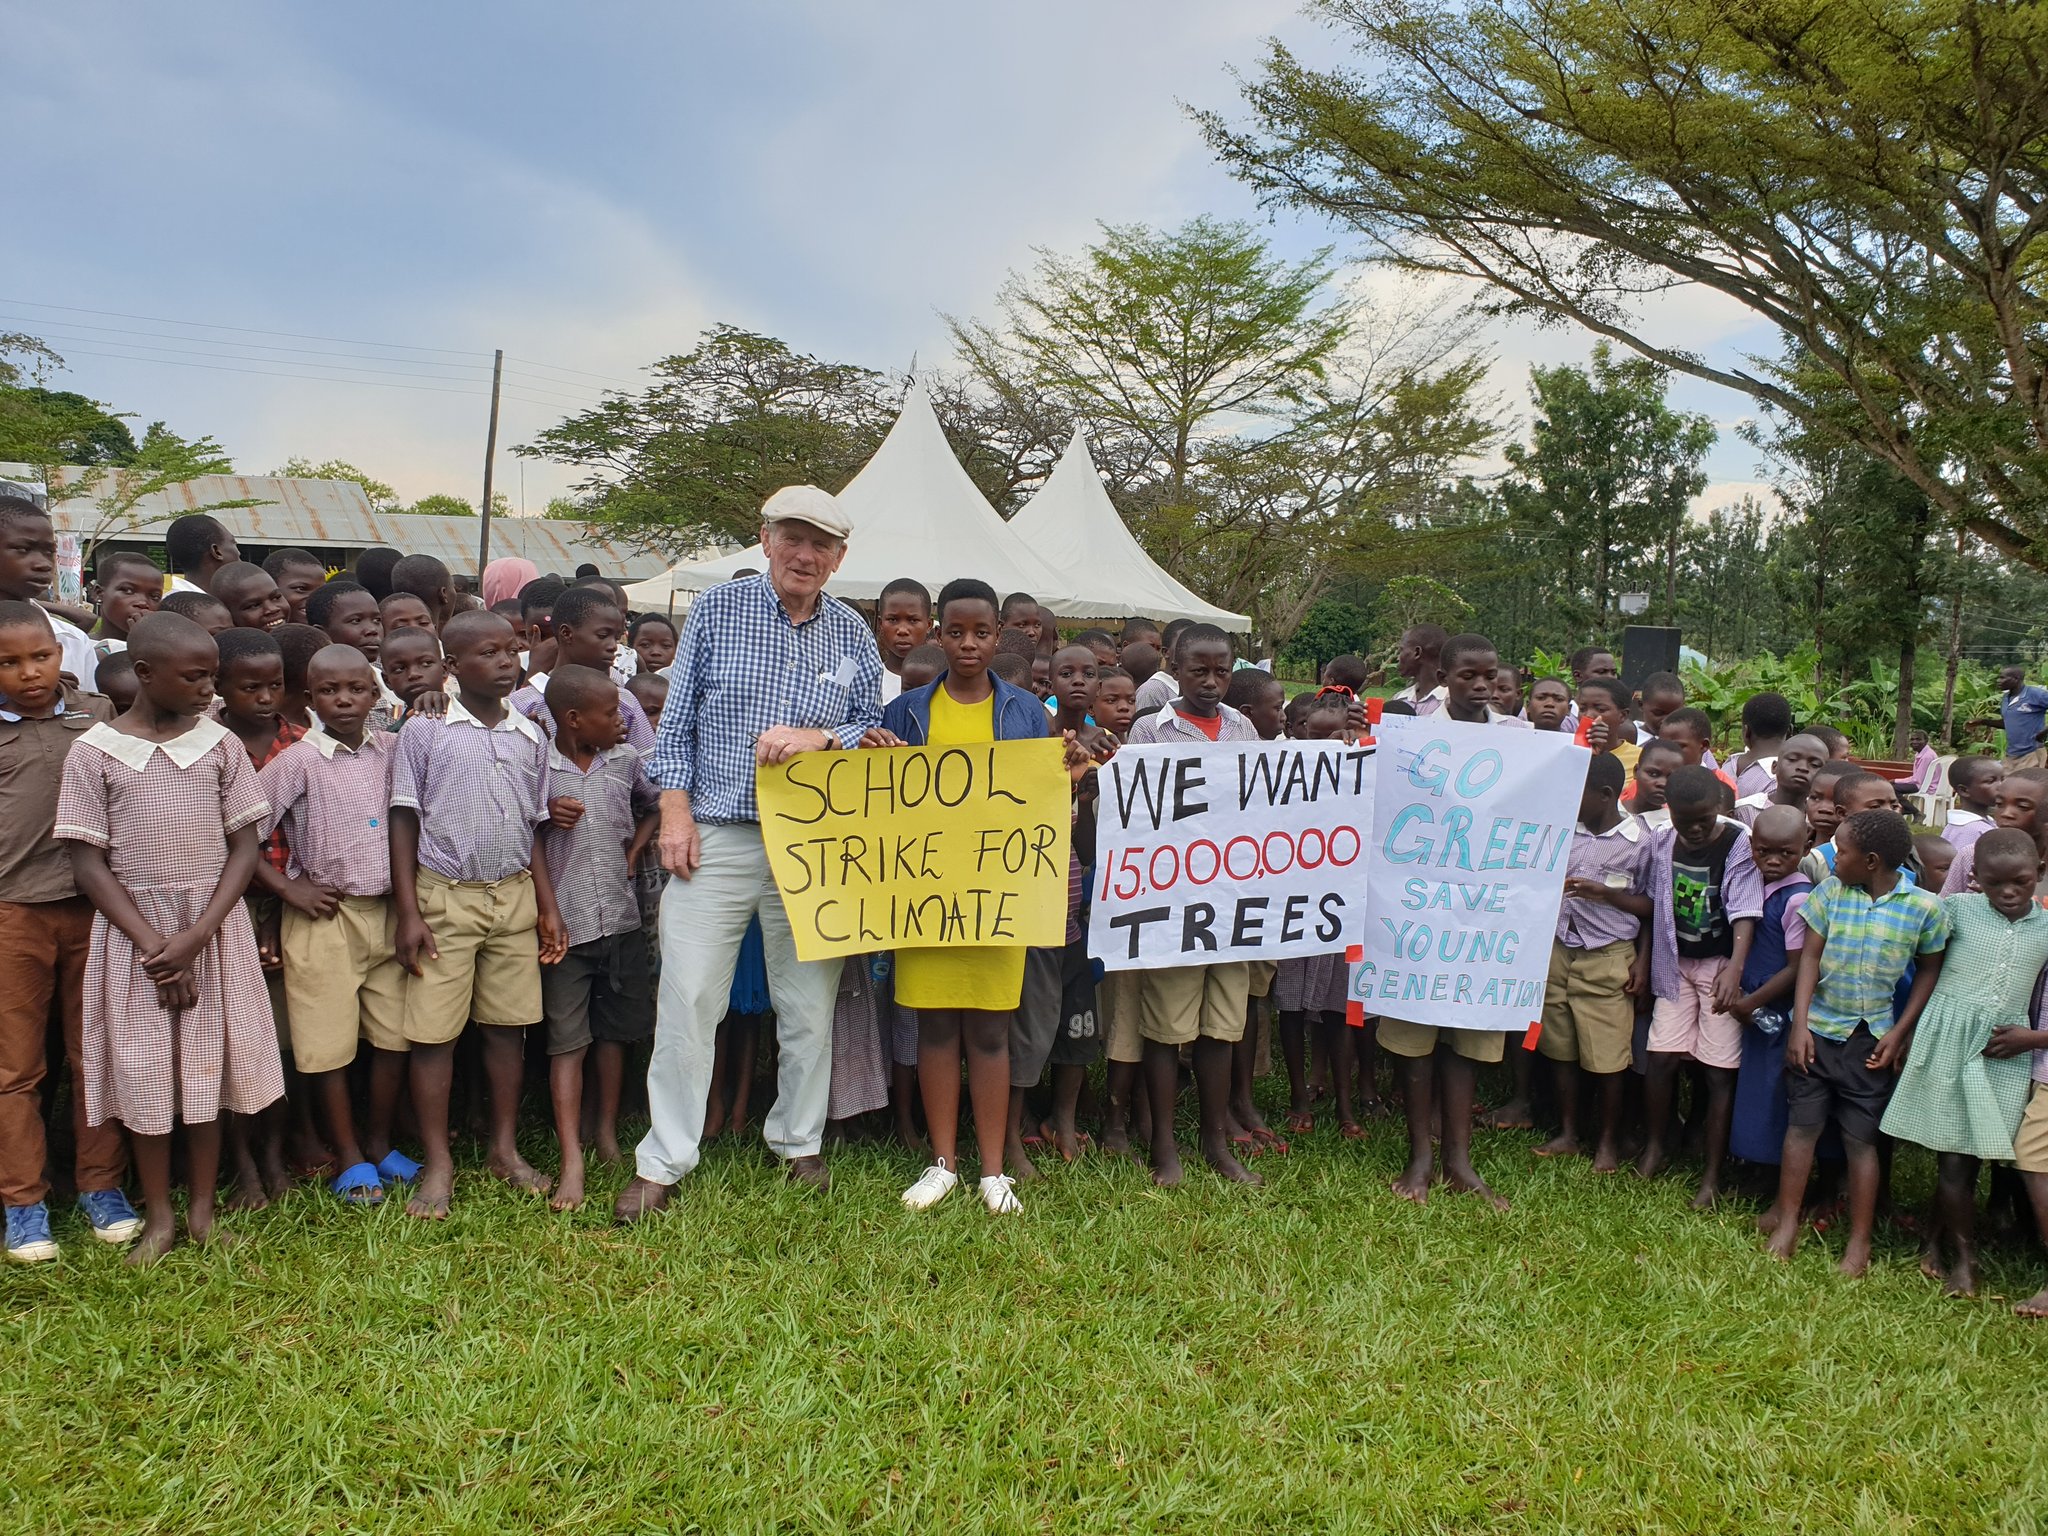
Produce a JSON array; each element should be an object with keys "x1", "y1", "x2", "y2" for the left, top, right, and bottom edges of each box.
[{"x1": 1352, "y1": 715, "x2": 1593, "y2": 1034}]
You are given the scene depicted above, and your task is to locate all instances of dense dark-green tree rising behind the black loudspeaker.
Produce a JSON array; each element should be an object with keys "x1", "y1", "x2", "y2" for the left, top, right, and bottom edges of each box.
[{"x1": 1501, "y1": 342, "x2": 1714, "y2": 635}]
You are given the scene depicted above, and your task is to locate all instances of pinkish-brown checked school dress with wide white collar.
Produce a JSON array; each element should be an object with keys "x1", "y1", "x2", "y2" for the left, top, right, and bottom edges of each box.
[{"x1": 55, "y1": 719, "x2": 285, "y2": 1137}]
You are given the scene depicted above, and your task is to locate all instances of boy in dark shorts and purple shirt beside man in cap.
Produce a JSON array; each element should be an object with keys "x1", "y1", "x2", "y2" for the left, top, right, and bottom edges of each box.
[{"x1": 541, "y1": 664, "x2": 659, "y2": 1210}]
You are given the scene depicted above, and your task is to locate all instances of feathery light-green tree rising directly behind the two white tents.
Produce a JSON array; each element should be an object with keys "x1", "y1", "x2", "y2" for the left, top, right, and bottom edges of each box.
[{"x1": 946, "y1": 219, "x2": 1350, "y2": 502}]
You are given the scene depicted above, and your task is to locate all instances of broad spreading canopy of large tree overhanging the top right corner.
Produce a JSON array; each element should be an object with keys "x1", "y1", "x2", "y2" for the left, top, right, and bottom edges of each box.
[{"x1": 1200, "y1": 0, "x2": 2048, "y2": 565}]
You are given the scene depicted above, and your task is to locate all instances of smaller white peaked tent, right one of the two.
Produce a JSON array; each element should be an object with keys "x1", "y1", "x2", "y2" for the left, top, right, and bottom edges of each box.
[{"x1": 1010, "y1": 428, "x2": 1251, "y2": 633}]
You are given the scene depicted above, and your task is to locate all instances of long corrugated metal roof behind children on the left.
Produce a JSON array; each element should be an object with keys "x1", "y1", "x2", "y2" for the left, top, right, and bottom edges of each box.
[{"x1": 36, "y1": 469, "x2": 668, "y2": 580}]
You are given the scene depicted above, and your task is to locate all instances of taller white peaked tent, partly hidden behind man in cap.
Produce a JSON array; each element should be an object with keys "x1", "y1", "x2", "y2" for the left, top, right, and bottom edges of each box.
[{"x1": 627, "y1": 385, "x2": 1069, "y2": 612}]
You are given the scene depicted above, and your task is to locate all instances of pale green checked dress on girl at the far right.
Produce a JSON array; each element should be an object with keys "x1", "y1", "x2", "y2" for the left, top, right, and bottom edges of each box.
[{"x1": 1884, "y1": 891, "x2": 2048, "y2": 1161}]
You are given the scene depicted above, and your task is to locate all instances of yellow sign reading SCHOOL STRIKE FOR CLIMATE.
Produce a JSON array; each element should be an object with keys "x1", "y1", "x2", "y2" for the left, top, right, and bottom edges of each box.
[{"x1": 754, "y1": 737, "x2": 1073, "y2": 961}]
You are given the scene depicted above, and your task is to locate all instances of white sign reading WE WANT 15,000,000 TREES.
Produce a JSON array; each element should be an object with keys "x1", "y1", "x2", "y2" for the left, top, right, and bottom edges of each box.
[{"x1": 1087, "y1": 741, "x2": 1372, "y2": 971}]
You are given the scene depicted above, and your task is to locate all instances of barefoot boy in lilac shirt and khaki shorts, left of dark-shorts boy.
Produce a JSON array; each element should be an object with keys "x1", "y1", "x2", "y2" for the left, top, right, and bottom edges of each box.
[{"x1": 391, "y1": 612, "x2": 567, "y2": 1219}]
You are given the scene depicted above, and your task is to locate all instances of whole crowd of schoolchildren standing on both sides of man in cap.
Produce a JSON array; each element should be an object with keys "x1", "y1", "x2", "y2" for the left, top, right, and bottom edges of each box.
[{"x1": 0, "y1": 496, "x2": 2048, "y2": 1317}]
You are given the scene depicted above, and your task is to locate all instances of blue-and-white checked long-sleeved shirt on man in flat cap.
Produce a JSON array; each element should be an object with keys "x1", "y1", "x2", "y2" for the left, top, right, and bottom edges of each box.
[{"x1": 647, "y1": 575, "x2": 883, "y2": 823}]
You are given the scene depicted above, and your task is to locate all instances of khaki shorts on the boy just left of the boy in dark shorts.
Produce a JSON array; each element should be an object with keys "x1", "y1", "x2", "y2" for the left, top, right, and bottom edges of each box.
[{"x1": 406, "y1": 868, "x2": 541, "y2": 1044}]
